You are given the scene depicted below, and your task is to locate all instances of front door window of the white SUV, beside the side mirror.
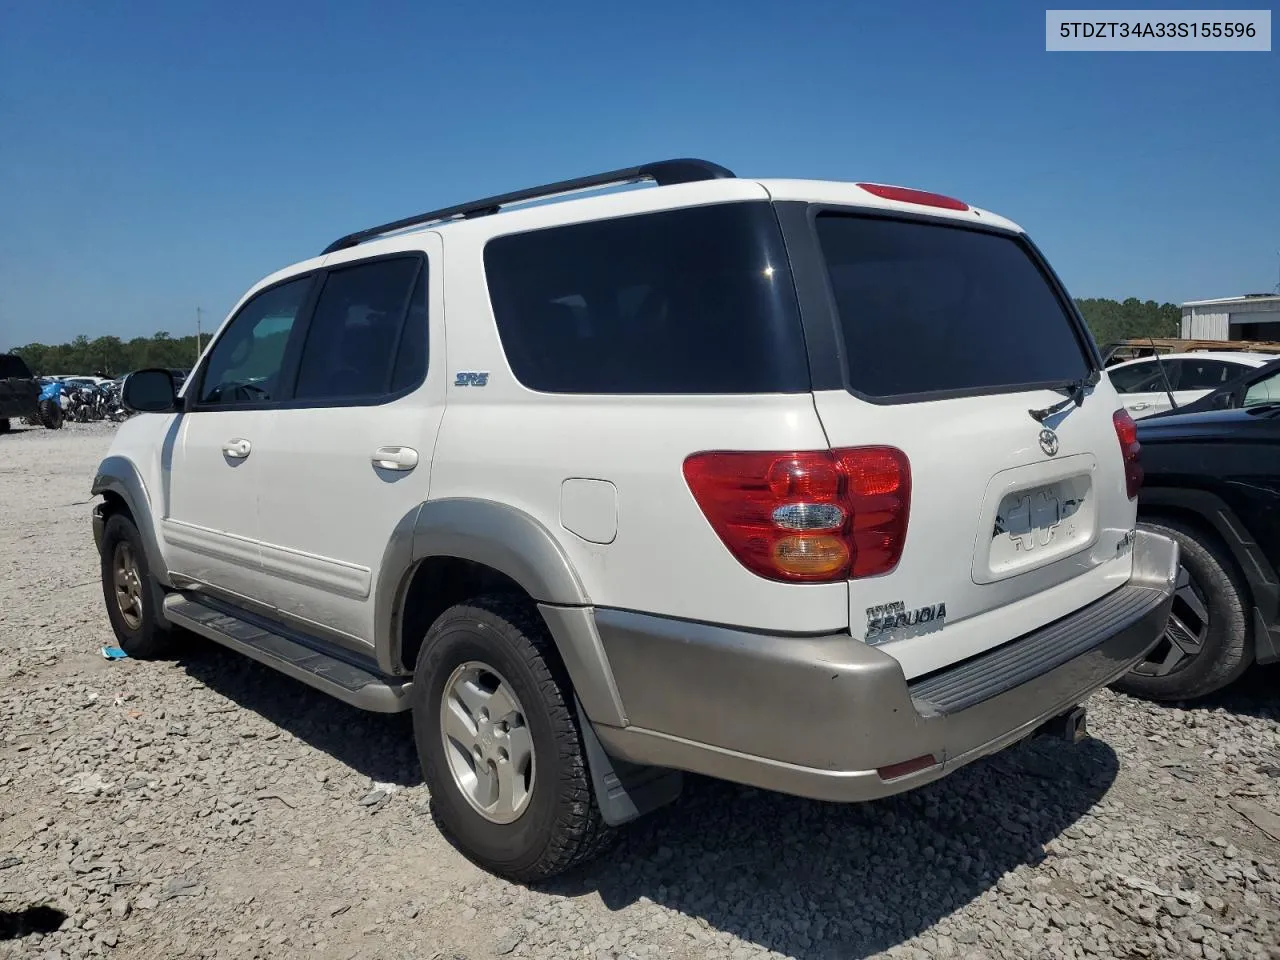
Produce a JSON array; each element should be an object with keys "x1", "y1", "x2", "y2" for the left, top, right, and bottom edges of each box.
[{"x1": 200, "y1": 275, "x2": 311, "y2": 406}]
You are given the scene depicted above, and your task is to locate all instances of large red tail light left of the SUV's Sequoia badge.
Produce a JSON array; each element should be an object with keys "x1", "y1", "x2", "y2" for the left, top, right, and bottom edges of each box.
[{"x1": 685, "y1": 447, "x2": 911, "y2": 582}]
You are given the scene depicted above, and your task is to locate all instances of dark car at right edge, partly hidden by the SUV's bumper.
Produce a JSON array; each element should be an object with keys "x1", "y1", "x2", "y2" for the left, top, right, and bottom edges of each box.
[{"x1": 1119, "y1": 404, "x2": 1280, "y2": 700}]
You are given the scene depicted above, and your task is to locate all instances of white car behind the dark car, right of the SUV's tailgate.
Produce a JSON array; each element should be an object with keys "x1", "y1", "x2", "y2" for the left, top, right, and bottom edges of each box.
[{"x1": 1107, "y1": 351, "x2": 1275, "y2": 420}]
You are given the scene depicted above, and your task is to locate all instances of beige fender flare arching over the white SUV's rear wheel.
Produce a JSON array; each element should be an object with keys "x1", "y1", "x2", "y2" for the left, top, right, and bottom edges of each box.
[{"x1": 374, "y1": 497, "x2": 625, "y2": 726}]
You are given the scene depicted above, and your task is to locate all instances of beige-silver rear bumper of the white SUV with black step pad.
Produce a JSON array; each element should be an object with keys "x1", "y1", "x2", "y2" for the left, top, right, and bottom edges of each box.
[{"x1": 595, "y1": 531, "x2": 1178, "y2": 801}]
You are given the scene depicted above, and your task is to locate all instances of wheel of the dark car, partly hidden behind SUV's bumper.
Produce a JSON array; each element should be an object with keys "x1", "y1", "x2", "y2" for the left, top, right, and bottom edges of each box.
[{"x1": 1115, "y1": 520, "x2": 1253, "y2": 700}]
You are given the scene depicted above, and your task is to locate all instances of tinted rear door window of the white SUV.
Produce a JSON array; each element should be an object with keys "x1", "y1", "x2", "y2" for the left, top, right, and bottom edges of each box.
[{"x1": 293, "y1": 257, "x2": 426, "y2": 401}]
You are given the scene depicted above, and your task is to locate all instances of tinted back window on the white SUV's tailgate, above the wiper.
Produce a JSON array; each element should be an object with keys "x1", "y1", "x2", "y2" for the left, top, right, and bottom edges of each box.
[{"x1": 818, "y1": 214, "x2": 1089, "y2": 398}]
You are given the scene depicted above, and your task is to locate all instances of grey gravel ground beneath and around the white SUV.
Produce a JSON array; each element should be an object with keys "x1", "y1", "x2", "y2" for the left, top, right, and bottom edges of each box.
[{"x1": 0, "y1": 424, "x2": 1280, "y2": 960}]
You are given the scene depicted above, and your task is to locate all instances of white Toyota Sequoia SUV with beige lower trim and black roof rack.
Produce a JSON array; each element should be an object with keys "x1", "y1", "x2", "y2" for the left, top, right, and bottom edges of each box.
[{"x1": 92, "y1": 160, "x2": 1178, "y2": 879}]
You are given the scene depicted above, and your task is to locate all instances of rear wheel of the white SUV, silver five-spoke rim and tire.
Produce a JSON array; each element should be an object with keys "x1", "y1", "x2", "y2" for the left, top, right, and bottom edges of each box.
[{"x1": 412, "y1": 596, "x2": 609, "y2": 882}]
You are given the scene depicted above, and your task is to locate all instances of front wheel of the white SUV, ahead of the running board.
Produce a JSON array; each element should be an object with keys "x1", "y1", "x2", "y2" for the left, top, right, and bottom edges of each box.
[{"x1": 101, "y1": 513, "x2": 172, "y2": 659}]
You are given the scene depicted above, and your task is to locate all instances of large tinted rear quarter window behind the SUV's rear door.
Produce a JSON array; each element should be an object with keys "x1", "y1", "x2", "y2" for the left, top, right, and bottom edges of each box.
[{"x1": 484, "y1": 202, "x2": 809, "y2": 394}]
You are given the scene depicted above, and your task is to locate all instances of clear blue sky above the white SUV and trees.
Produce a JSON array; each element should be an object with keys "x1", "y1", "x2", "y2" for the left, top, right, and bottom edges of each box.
[{"x1": 0, "y1": 0, "x2": 1280, "y2": 348}]
